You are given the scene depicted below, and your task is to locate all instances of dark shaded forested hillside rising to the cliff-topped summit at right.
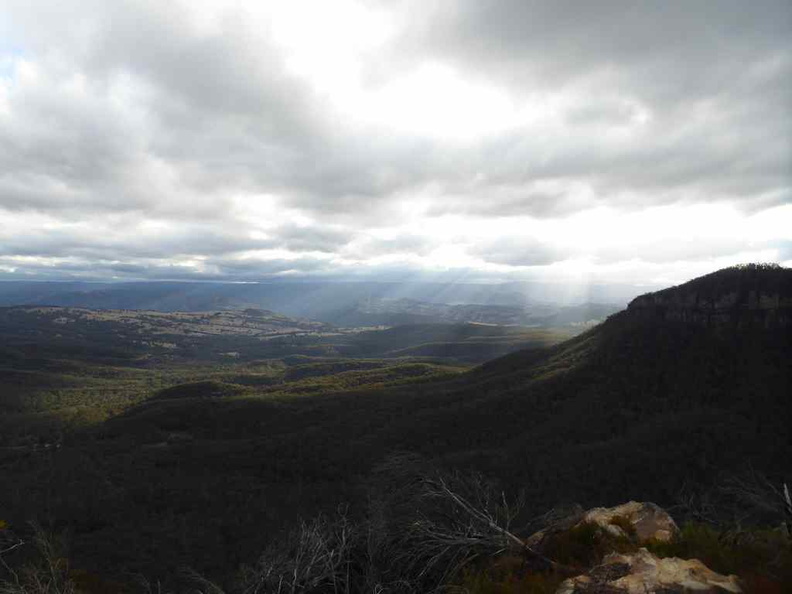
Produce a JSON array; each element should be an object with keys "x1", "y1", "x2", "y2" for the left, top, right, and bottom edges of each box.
[{"x1": 0, "y1": 267, "x2": 792, "y2": 576}]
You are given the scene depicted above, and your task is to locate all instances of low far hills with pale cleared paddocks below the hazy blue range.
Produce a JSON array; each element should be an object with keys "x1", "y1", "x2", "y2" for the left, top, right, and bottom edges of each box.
[{"x1": 0, "y1": 306, "x2": 572, "y2": 368}]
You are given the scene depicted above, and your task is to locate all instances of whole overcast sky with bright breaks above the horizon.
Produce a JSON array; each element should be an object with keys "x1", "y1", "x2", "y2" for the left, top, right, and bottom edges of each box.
[{"x1": 0, "y1": 0, "x2": 792, "y2": 286}]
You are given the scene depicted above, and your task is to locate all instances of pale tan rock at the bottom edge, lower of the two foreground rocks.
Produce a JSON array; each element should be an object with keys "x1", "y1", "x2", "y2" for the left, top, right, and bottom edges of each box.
[{"x1": 556, "y1": 549, "x2": 742, "y2": 594}]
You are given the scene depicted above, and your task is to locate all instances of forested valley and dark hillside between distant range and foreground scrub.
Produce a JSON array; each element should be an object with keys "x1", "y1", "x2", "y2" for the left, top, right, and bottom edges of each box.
[{"x1": 0, "y1": 267, "x2": 792, "y2": 587}]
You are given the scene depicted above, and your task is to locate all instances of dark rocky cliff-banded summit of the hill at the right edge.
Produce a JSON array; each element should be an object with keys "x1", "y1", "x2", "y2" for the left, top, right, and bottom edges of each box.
[{"x1": 627, "y1": 264, "x2": 792, "y2": 328}]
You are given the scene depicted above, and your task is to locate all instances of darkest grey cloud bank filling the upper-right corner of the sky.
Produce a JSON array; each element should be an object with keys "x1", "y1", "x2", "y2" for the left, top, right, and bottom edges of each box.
[{"x1": 406, "y1": 0, "x2": 791, "y2": 95}]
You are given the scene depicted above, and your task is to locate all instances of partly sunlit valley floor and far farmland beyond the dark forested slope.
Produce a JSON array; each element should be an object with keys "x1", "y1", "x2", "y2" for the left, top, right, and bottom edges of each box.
[{"x1": 0, "y1": 307, "x2": 569, "y2": 447}]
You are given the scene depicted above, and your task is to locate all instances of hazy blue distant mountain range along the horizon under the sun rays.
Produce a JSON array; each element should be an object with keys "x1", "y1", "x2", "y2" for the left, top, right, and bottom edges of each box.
[{"x1": 0, "y1": 282, "x2": 626, "y2": 327}]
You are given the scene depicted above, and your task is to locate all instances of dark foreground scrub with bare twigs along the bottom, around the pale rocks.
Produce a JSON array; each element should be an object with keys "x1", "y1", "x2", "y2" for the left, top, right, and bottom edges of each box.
[{"x1": 0, "y1": 462, "x2": 792, "y2": 594}]
